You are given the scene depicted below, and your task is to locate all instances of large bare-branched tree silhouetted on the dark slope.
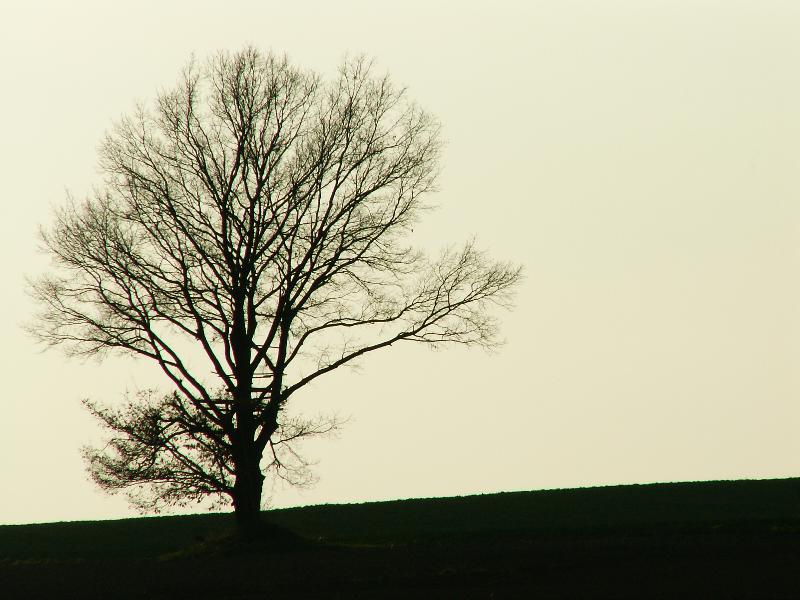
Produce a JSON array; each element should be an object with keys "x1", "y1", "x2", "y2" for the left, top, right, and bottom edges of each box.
[{"x1": 30, "y1": 48, "x2": 520, "y2": 530}]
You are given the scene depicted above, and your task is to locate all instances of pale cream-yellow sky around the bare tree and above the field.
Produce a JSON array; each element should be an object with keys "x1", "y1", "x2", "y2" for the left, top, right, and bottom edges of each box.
[{"x1": 0, "y1": 0, "x2": 800, "y2": 523}]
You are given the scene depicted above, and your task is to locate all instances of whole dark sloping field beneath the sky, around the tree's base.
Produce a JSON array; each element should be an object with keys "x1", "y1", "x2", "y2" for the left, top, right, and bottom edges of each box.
[{"x1": 0, "y1": 479, "x2": 800, "y2": 600}]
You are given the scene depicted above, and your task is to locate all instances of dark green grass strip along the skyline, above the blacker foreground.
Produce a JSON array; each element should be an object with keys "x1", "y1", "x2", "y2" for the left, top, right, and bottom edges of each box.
[{"x1": 0, "y1": 479, "x2": 800, "y2": 563}]
